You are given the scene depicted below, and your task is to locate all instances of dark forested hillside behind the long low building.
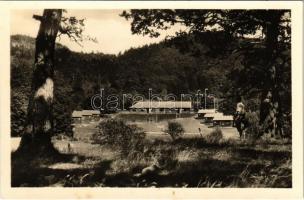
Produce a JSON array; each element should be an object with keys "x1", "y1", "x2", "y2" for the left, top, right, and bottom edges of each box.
[{"x1": 11, "y1": 31, "x2": 291, "y2": 136}]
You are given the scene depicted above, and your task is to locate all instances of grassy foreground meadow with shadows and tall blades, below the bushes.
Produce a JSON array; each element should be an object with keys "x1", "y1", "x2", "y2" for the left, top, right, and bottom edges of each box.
[{"x1": 12, "y1": 114, "x2": 292, "y2": 188}]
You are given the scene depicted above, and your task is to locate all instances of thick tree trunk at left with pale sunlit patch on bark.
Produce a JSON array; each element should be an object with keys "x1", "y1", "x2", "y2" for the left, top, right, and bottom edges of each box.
[{"x1": 19, "y1": 9, "x2": 62, "y2": 153}]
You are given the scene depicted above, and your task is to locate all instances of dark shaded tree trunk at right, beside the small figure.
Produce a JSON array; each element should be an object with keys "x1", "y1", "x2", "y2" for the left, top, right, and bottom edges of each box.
[{"x1": 260, "y1": 11, "x2": 282, "y2": 136}]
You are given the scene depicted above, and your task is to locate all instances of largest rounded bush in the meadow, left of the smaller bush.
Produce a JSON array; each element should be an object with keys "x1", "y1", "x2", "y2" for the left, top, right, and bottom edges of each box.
[{"x1": 93, "y1": 119, "x2": 145, "y2": 155}]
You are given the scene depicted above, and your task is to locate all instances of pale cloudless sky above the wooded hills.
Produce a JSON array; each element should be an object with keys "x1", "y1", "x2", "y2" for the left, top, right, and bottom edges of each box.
[{"x1": 11, "y1": 10, "x2": 181, "y2": 54}]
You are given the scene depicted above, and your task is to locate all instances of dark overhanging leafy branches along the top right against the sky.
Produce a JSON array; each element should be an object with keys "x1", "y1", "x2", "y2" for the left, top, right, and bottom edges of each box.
[{"x1": 121, "y1": 9, "x2": 290, "y2": 39}]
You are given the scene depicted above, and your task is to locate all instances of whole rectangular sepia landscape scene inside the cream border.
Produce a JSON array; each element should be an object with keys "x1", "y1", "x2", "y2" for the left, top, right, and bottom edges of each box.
[{"x1": 0, "y1": 0, "x2": 303, "y2": 198}]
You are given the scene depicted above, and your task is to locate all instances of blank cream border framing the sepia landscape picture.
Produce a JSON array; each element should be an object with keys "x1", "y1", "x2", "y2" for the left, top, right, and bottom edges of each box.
[{"x1": 0, "y1": 1, "x2": 303, "y2": 199}]
